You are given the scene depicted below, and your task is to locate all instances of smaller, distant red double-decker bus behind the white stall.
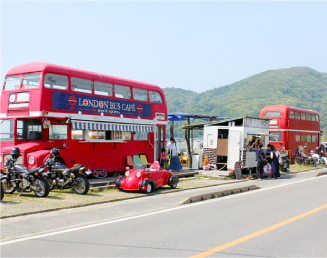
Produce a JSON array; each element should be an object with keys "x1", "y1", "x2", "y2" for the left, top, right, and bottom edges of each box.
[{"x1": 260, "y1": 106, "x2": 320, "y2": 161}]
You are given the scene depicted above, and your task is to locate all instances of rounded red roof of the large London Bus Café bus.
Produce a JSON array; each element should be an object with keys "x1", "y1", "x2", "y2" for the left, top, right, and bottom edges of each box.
[{"x1": 6, "y1": 62, "x2": 163, "y2": 93}]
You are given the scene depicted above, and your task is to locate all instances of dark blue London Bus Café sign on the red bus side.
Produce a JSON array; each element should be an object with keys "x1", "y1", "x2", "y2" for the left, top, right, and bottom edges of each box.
[{"x1": 52, "y1": 91, "x2": 152, "y2": 118}]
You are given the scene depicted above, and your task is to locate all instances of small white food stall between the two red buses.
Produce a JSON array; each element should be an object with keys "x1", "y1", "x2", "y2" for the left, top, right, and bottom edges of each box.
[{"x1": 203, "y1": 117, "x2": 270, "y2": 173}]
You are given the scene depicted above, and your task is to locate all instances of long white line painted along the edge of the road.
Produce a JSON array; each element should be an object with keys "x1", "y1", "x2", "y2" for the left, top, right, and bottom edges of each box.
[{"x1": 0, "y1": 175, "x2": 327, "y2": 246}]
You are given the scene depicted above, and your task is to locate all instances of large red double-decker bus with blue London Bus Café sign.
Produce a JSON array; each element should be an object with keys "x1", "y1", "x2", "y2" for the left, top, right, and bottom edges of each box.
[{"x1": 0, "y1": 63, "x2": 167, "y2": 172}]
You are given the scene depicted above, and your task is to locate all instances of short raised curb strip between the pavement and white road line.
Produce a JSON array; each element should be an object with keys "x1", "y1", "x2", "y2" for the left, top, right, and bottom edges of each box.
[{"x1": 179, "y1": 184, "x2": 262, "y2": 205}]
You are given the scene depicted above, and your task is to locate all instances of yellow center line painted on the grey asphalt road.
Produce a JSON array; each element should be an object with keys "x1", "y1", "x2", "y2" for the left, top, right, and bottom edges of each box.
[{"x1": 191, "y1": 204, "x2": 327, "y2": 258}]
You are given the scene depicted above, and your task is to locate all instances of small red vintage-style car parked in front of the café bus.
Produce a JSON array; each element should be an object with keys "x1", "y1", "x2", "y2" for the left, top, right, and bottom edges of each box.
[{"x1": 115, "y1": 161, "x2": 179, "y2": 193}]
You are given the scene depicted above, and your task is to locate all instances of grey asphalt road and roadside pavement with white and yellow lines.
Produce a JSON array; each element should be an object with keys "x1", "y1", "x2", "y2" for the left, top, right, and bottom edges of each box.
[{"x1": 0, "y1": 172, "x2": 327, "y2": 257}]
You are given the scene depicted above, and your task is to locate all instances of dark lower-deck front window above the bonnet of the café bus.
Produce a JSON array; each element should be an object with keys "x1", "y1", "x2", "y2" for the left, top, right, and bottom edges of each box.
[{"x1": 17, "y1": 119, "x2": 42, "y2": 140}]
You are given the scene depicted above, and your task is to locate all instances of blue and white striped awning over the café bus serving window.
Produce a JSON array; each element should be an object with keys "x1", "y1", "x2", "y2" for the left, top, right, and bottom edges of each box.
[{"x1": 72, "y1": 121, "x2": 154, "y2": 132}]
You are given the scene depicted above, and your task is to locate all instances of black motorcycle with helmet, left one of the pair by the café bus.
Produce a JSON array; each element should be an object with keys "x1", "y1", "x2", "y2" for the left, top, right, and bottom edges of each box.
[{"x1": 1, "y1": 153, "x2": 50, "y2": 197}]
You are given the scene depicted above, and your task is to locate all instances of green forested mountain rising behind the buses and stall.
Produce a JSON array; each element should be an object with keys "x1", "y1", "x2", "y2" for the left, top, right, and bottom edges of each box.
[{"x1": 163, "y1": 67, "x2": 327, "y2": 137}]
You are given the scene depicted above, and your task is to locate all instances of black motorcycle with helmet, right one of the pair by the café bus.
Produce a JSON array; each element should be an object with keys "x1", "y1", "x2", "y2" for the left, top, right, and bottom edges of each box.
[{"x1": 44, "y1": 153, "x2": 92, "y2": 194}]
